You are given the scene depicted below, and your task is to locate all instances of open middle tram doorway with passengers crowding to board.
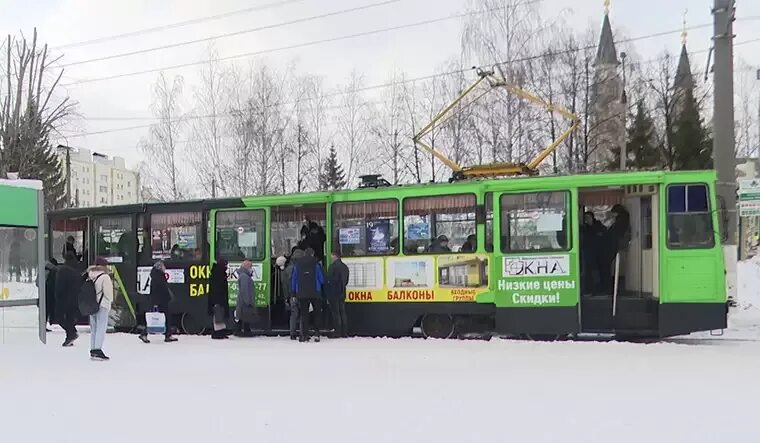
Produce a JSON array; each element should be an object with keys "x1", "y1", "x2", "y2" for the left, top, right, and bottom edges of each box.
[{"x1": 269, "y1": 203, "x2": 328, "y2": 331}]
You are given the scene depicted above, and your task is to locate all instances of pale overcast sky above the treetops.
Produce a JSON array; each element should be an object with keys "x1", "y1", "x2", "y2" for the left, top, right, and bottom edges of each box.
[{"x1": 0, "y1": 0, "x2": 760, "y2": 166}]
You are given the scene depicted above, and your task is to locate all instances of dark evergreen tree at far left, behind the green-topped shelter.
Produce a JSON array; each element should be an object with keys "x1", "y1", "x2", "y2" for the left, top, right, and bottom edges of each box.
[{"x1": 2, "y1": 108, "x2": 66, "y2": 209}]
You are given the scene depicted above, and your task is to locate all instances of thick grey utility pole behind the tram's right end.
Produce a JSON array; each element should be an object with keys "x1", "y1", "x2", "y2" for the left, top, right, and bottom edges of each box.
[{"x1": 712, "y1": 0, "x2": 738, "y2": 302}]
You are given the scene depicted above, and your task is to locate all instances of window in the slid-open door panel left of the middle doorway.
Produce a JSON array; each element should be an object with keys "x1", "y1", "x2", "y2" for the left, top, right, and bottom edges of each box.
[{"x1": 215, "y1": 210, "x2": 266, "y2": 262}]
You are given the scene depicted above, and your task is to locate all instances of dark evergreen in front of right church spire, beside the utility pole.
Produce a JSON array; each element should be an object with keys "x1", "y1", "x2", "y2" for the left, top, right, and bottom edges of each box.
[{"x1": 673, "y1": 89, "x2": 713, "y2": 170}]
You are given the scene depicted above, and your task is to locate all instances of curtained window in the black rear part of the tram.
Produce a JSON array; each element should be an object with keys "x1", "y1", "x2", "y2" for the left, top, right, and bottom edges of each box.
[{"x1": 150, "y1": 212, "x2": 203, "y2": 261}]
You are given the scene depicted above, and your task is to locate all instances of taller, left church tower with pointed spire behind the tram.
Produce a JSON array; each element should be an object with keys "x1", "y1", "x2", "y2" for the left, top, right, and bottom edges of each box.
[{"x1": 587, "y1": 0, "x2": 626, "y2": 172}]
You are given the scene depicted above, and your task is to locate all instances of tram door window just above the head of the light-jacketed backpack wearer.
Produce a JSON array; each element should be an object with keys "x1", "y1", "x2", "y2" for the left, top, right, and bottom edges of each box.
[{"x1": 92, "y1": 216, "x2": 137, "y2": 264}]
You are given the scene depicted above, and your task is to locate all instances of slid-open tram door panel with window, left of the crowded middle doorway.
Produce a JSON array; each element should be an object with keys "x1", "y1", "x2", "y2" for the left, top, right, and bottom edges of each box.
[{"x1": 209, "y1": 208, "x2": 271, "y2": 331}]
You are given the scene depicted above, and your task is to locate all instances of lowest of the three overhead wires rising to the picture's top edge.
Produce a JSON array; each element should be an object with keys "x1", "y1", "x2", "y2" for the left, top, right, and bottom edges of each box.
[{"x1": 61, "y1": 7, "x2": 508, "y2": 86}]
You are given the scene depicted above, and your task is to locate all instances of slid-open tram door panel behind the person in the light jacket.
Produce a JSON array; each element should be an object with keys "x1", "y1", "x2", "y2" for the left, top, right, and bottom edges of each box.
[{"x1": 89, "y1": 214, "x2": 137, "y2": 329}]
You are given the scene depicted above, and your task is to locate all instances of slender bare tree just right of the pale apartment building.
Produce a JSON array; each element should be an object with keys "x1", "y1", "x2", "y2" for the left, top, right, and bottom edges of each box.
[{"x1": 139, "y1": 72, "x2": 187, "y2": 201}]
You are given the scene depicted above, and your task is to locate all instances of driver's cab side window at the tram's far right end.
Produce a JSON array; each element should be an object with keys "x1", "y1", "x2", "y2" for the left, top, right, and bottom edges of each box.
[{"x1": 668, "y1": 184, "x2": 715, "y2": 249}]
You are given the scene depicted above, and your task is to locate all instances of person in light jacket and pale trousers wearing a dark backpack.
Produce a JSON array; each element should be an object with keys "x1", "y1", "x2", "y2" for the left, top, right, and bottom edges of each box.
[{"x1": 85, "y1": 257, "x2": 113, "y2": 361}]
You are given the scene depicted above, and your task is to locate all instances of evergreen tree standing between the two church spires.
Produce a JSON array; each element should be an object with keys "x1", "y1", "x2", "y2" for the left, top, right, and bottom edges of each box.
[{"x1": 607, "y1": 100, "x2": 662, "y2": 171}]
